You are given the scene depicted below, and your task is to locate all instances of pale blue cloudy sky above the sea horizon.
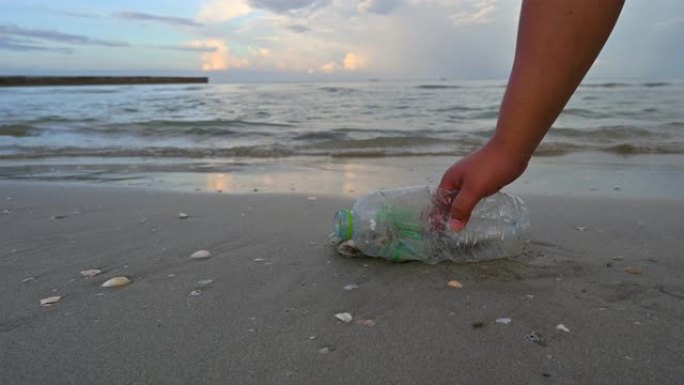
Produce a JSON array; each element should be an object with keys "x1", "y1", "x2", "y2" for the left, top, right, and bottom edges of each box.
[{"x1": 0, "y1": 0, "x2": 684, "y2": 81}]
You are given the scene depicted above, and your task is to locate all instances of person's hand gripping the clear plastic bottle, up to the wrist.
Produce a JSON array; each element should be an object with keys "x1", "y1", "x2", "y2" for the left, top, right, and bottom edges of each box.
[{"x1": 439, "y1": 140, "x2": 529, "y2": 231}]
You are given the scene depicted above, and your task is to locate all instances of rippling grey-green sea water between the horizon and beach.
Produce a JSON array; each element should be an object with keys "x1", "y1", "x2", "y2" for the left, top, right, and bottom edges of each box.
[{"x1": 0, "y1": 79, "x2": 684, "y2": 196}]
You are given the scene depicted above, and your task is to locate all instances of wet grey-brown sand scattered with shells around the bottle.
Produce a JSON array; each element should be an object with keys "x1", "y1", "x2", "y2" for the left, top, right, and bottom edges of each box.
[{"x1": 0, "y1": 182, "x2": 684, "y2": 384}]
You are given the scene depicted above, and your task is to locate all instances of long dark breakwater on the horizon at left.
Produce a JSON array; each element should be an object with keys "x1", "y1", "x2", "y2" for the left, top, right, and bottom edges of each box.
[{"x1": 0, "y1": 76, "x2": 209, "y2": 87}]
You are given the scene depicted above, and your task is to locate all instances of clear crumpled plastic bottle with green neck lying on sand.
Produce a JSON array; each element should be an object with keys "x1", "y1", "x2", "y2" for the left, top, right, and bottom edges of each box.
[{"x1": 334, "y1": 186, "x2": 530, "y2": 263}]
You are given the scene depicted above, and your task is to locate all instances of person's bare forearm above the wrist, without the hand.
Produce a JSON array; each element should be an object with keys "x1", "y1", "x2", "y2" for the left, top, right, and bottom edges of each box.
[{"x1": 492, "y1": 0, "x2": 624, "y2": 161}]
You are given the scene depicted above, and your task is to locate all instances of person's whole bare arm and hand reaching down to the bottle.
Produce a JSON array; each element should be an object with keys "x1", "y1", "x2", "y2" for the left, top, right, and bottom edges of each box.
[{"x1": 439, "y1": 0, "x2": 624, "y2": 231}]
